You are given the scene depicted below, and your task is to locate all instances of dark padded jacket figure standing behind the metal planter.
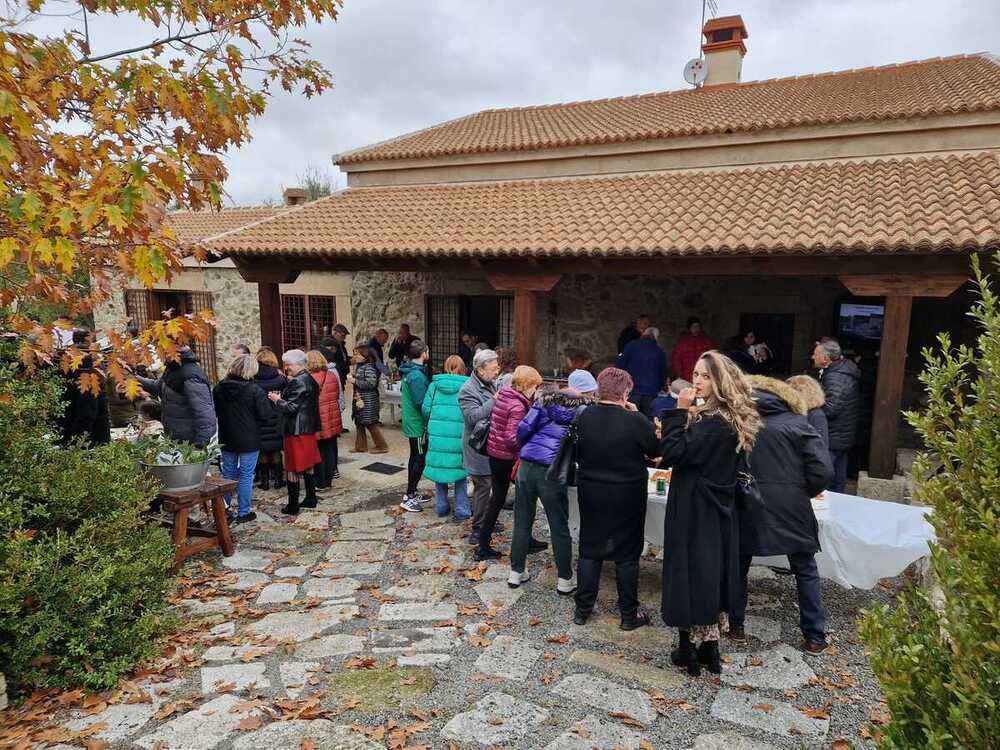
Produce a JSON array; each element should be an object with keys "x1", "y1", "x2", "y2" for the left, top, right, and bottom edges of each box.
[{"x1": 137, "y1": 346, "x2": 218, "y2": 448}]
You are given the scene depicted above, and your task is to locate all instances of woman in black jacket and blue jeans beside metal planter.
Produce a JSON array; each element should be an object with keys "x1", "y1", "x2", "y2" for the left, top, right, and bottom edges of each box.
[{"x1": 212, "y1": 354, "x2": 273, "y2": 524}]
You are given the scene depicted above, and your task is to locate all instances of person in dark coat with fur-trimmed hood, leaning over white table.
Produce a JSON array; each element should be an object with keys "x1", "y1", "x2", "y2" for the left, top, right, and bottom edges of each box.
[{"x1": 729, "y1": 376, "x2": 833, "y2": 654}]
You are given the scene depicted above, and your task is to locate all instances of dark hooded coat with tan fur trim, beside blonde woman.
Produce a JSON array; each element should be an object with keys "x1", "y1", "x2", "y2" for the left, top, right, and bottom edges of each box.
[{"x1": 738, "y1": 375, "x2": 833, "y2": 556}]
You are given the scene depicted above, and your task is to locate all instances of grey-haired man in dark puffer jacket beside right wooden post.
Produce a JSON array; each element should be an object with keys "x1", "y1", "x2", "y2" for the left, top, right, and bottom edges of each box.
[{"x1": 813, "y1": 338, "x2": 861, "y2": 492}]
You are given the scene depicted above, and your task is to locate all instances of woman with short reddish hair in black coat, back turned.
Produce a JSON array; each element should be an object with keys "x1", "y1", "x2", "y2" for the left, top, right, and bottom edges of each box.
[{"x1": 573, "y1": 367, "x2": 659, "y2": 630}]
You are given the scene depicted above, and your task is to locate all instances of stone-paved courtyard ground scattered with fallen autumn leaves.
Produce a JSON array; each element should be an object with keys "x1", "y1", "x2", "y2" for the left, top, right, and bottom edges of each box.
[{"x1": 35, "y1": 472, "x2": 891, "y2": 750}]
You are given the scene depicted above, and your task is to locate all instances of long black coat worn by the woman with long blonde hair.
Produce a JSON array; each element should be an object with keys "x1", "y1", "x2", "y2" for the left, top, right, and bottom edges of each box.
[{"x1": 660, "y1": 409, "x2": 740, "y2": 628}]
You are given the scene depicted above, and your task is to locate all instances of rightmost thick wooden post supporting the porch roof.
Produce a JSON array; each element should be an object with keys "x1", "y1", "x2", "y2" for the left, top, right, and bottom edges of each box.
[{"x1": 868, "y1": 295, "x2": 913, "y2": 479}]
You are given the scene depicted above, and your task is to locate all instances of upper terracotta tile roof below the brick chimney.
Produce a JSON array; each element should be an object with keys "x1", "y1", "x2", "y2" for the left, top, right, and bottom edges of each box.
[{"x1": 338, "y1": 55, "x2": 1000, "y2": 164}]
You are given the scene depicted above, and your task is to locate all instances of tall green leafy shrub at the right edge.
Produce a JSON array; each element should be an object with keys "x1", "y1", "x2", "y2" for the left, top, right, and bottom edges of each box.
[{"x1": 861, "y1": 256, "x2": 1000, "y2": 750}]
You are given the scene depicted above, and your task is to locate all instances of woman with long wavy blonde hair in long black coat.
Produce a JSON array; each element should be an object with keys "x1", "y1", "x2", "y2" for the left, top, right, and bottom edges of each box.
[{"x1": 661, "y1": 350, "x2": 760, "y2": 676}]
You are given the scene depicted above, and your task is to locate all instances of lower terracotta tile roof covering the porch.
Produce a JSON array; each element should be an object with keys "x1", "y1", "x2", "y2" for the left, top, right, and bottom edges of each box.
[{"x1": 208, "y1": 152, "x2": 1000, "y2": 258}]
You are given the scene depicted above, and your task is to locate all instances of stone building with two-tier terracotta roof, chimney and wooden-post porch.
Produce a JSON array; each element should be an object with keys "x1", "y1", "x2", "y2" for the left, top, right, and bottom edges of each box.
[{"x1": 199, "y1": 16, "x2": 1000, "y2": 488}]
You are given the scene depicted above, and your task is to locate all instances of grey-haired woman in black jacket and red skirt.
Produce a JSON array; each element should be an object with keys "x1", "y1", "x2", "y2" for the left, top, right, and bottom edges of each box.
[{"x1": 267, "y1": 349, "x2": 323, "y2": 516}]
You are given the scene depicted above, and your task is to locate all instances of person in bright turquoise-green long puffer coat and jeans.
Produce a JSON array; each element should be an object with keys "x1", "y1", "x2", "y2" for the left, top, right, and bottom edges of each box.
[{"x1": 421, "y1": 354, "x2": 472, "y2": 521}]
